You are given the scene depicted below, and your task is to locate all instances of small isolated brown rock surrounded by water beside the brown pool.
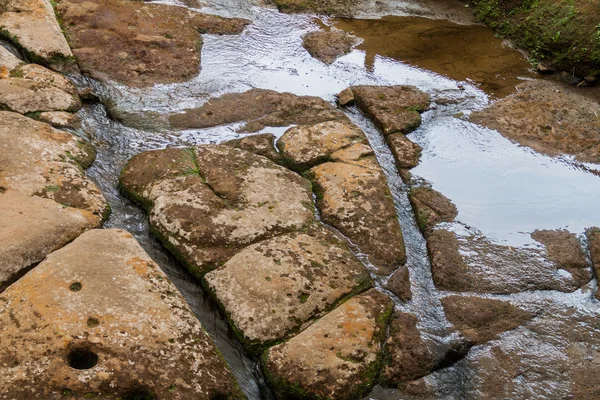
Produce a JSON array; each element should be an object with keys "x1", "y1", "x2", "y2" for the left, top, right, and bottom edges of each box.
[{"x1": 302, "y1": 31, "x2": 357, "y2": 64}]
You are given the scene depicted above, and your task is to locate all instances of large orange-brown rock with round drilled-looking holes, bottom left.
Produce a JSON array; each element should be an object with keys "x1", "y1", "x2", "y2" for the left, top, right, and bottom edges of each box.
[{"x1": 0, "y1": 229, "x2": 243, "y2": 400}]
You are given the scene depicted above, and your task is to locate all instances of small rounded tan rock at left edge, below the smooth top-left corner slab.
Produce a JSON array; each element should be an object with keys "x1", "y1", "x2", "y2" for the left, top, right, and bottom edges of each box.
[{"x1": 0, "y1": 78, "x2": 81, "y2": 114}]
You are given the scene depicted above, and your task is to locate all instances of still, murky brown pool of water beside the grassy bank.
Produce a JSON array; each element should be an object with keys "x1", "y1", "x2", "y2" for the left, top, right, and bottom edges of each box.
[{"x1": 333, "y1": 16, "x2": 537, "y2": 97}]
